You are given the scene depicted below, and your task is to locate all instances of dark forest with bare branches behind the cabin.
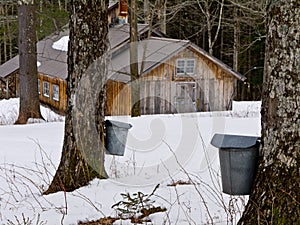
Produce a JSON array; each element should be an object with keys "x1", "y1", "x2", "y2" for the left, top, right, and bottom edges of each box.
[{"x1": 0, "y1": 0, "x2": 266, "y2": 100}]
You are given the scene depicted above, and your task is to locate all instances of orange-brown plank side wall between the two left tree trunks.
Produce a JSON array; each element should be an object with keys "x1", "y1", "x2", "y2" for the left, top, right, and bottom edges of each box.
[{"x1": 38, "y1": 74, "x2": 67, "y2": 114}]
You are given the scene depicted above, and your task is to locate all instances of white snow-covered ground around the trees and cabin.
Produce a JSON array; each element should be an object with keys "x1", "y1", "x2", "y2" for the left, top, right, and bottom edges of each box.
[{"x1": 0, "y1": 99, "x2": 260, "y2": 225}]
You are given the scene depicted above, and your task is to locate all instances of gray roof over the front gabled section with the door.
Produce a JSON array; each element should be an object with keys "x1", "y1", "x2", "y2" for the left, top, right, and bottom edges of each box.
[{"x1": 108, "y1": 37, "x2": 246, "y2": 83}]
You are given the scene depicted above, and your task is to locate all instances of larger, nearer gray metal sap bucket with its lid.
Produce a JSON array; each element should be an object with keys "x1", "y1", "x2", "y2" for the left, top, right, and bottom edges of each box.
[{"x1": 211, "y1": 134, "x2": 260, "y2": 195}]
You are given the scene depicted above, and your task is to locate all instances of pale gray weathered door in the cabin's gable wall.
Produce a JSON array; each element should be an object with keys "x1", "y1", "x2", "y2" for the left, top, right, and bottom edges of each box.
[{"x1": 175, "y1": 82, "x2": 197, "y2": 113}]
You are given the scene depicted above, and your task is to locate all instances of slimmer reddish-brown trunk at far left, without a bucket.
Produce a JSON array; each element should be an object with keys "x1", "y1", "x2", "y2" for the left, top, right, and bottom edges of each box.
[{"x1": 16, "y1": 1, "x2": 42, "y2": 124}]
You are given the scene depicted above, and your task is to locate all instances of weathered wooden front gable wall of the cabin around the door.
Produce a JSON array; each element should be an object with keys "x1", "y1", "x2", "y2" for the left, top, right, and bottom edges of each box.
[{"x1": 137, "y1": 49, "x2": 235, "y2": 114}]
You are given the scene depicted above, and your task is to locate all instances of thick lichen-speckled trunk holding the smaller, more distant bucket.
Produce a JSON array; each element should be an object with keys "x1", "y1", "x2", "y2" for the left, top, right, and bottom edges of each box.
[{"x1": 45, "y1": 0, "x2": 108, "y2": 194}]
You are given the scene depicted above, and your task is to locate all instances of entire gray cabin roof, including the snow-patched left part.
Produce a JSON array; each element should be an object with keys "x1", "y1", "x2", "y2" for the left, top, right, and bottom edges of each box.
[{"x1": 0, "y1": 24, "x2": 246, "y2": 83}]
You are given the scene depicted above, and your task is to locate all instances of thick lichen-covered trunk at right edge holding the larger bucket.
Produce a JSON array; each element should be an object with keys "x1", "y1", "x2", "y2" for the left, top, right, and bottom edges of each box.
[{"x1": 238, "y1": 0, "x2": 300, "y2": 224}]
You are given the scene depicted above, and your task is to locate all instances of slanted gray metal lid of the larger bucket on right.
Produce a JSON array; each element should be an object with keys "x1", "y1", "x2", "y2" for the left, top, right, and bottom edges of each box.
[{"x1": 210, "y1": 134, "x2": 260, "y2": 148}]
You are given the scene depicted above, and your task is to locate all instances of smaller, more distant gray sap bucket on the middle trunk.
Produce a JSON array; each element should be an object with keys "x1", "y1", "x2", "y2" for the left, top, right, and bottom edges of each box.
[{"x1": 105, "y1": 120, "x2": 132, "y2": 156}]
